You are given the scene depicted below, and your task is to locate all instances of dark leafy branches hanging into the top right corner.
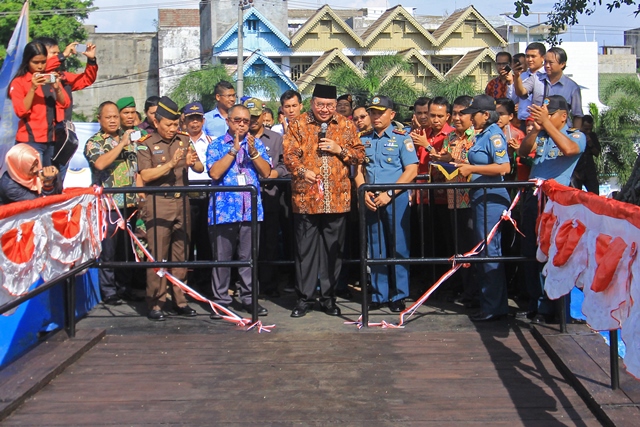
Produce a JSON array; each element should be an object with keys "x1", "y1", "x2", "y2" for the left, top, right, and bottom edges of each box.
[{"x1": 514, "y1": 0, "x2": 640, "y2": 45}]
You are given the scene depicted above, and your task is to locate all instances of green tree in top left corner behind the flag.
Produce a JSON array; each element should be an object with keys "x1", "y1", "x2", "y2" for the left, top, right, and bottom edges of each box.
[{"x1": 0, "y1": 0, "x2": 93, "y2": 69}]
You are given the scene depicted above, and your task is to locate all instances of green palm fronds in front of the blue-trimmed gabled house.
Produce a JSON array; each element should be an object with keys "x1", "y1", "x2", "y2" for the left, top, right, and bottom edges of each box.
[{"x1": 169, "y1": 64, "x2": 279, "y2": 111}]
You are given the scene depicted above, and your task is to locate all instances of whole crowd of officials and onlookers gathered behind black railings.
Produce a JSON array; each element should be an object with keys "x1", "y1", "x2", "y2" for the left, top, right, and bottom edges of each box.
[{"x1": 0, "y1": 39, "x2": 600, "y2": 322}]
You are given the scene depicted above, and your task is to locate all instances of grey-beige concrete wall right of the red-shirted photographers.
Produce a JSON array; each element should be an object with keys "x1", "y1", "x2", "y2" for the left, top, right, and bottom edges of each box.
[{"x1": 73, "y1": 33, "x2": 158, "y2": 120}]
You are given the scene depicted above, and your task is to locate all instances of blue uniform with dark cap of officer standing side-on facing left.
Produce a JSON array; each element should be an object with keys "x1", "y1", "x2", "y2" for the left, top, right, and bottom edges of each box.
[{"x1": 462, "y1": 95, "x2": 510, "y2": 320}]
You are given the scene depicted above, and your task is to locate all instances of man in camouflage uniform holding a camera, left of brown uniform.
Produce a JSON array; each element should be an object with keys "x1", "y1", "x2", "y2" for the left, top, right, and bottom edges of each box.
[{"x1": 84, "y1": 101, "x2": 148, "y2": 305}]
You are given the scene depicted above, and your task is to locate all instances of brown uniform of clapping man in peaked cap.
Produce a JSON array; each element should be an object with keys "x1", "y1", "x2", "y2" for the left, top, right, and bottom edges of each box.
[{"x1": 138, "y1": 133, "x2": 190, "y2": 310}]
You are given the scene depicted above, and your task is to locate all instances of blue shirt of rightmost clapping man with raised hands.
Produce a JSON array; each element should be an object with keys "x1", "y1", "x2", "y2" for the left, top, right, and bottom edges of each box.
[{"x1": 529, "y1": 124, "x2": 587, "y2": 185}]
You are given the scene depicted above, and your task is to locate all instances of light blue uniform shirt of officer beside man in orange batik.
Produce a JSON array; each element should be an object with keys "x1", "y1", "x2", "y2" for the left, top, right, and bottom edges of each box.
[{"x1": 360, "y1": 126, "x2": 418, "y2": 184}]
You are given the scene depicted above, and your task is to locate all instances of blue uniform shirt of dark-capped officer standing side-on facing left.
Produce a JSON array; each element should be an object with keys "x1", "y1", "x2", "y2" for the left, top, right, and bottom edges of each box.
[{"x1": 467, "y1": 123, "x2": 509, "y2": 199}]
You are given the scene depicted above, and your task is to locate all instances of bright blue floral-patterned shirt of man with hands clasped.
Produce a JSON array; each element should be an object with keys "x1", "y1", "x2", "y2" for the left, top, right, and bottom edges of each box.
[{"x1": 206, "y1": 133, "x2": 269, "y2": 225}]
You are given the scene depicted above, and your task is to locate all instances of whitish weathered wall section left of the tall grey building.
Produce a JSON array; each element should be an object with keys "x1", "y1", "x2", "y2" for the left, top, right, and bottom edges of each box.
[{"x1": 158, "y1": 27, "x2": 200, "y2": 96}]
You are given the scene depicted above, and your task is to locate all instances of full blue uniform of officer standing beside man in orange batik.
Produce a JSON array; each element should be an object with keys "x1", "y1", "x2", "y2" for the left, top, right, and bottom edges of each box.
[{"x1": 360, "y1": 108, "x2": 418, "y2": 303}]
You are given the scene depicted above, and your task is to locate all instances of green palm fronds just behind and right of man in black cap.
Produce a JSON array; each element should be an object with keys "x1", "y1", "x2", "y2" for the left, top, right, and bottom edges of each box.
[{"x1": 327, "y1": 55, "x2": 417, "y2": 119}]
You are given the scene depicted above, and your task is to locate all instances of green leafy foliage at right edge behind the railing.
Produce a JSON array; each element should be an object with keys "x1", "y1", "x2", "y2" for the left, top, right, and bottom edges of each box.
[{"x1": 594, "y1": 77, "x2": 640, "y2": 185}]
